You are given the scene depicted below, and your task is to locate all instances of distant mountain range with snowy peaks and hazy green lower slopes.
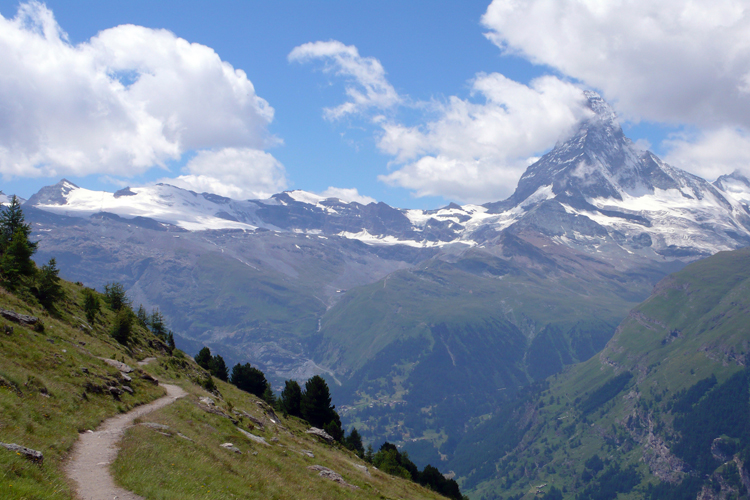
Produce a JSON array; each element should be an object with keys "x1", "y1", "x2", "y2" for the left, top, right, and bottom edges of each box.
[{"x1": 10, "y1": 92, "x2": 750, "y2": 484}]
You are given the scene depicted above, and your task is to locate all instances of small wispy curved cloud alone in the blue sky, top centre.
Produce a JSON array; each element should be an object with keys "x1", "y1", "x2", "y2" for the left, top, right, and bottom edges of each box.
[{"x1": 288, "y1": 40, "x2": 401, "y2": 120}]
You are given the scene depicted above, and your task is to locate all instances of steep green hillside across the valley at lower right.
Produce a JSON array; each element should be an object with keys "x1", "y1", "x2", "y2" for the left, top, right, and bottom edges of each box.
[{"x1": 468, "y1": 249, "x2": 750, "y2": 500}]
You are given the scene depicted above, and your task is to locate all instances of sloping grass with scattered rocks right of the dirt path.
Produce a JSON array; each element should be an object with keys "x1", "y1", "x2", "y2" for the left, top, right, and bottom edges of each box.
[{"x1": 113, "y1": 356, "x2": 452, "y2": 500}]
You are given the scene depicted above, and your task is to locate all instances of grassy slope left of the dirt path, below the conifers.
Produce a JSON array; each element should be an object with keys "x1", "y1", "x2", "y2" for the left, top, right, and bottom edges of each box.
[{"x1": 0, "y1": 283, "x2": 169, "y2": 499}]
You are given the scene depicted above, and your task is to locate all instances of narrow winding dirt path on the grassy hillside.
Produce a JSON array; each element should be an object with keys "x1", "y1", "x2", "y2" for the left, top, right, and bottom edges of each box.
[{"x1": 65, "y1": 384, "x2": 187, "y2": 500}]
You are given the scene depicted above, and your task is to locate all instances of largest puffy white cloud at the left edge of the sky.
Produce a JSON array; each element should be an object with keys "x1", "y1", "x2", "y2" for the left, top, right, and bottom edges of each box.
[{"x1": 0, "y1": 2, "x2": 276, "y2": 182}]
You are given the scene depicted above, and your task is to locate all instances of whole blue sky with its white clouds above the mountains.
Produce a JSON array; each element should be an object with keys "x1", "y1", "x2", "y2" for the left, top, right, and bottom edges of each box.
[{"x1": 0, "y1": 0, "x2": 750, "y2": 208}]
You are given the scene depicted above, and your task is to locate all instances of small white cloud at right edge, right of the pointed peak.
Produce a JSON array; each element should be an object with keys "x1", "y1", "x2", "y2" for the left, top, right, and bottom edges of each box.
[{"x1": 664, "y1": 127, "x2": 750, "y2": 180}]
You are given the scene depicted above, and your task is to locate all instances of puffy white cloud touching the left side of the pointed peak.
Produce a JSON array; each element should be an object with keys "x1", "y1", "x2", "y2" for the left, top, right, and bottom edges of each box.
[{"x1": 378, "y1": 73, "x2": 590, "y2": 202}]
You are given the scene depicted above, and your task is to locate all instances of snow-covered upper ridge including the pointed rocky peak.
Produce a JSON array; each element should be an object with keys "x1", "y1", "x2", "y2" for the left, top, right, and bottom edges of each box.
[{"x1": 22, "y1": 92, "x2": 750, "y2": 260}]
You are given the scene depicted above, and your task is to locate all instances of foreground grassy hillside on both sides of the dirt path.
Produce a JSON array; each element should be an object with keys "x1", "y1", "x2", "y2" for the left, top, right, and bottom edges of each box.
[{"x1": 0, "y1": 283, "x2": 458, "y2": 499}]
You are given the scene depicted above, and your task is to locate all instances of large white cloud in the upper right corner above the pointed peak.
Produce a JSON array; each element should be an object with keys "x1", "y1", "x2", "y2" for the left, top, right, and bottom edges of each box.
[{"x1": 482, "y1": 0, "x2": 750, "y2": 127}]
